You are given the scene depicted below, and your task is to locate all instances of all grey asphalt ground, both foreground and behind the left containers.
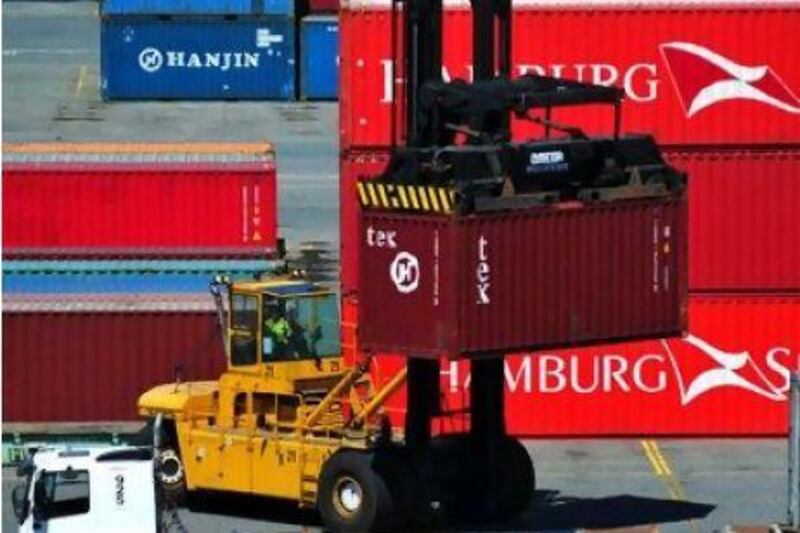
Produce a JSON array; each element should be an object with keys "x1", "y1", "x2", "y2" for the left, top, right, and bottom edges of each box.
[{"x1": 2, "y1": 2, "x2": 787, "y2": 533}]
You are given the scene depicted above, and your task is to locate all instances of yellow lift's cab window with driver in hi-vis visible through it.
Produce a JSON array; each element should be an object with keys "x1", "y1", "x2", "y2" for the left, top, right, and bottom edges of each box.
[{"x1": 264, "y1": 294, "x2": 340, "y2": 361}]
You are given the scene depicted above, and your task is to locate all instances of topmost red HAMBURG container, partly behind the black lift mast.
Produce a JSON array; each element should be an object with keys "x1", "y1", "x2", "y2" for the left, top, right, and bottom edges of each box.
[{"x1": 340, "y1": 0, "x2": 800, "y2": 148}]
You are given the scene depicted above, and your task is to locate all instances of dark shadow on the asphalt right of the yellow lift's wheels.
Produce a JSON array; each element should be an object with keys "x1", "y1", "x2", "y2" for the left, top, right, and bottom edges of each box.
[{"x1": 500, "y1": 490, "x2": 716, "y2": 531}]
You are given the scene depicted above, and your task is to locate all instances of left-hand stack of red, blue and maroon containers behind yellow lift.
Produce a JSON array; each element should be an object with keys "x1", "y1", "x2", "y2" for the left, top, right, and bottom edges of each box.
[{"x1": 3, "y1": 143, "x2": 278, "y2": 423}]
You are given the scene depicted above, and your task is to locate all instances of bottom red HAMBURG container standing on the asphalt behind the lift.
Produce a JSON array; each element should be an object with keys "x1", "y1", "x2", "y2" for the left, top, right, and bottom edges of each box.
[{"x1": 354, "y1": 294, "x2": 800, "y2": 438}]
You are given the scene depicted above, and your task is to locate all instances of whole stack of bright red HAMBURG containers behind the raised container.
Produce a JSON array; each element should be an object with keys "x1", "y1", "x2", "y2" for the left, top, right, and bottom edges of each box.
[{"x1": 340, "y1": 0, "x2": 800, "y2": 435}]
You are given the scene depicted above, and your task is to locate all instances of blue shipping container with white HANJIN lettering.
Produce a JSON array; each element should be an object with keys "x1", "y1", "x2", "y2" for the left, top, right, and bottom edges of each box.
[{"x1": 100, "y1": 16, "x2": 295, "y2": 100}]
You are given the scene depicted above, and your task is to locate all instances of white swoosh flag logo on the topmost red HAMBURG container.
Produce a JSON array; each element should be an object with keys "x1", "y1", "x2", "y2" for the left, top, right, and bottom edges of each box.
[{"x1": 661, "y1": 42, "x2": 800, "y2": 117}]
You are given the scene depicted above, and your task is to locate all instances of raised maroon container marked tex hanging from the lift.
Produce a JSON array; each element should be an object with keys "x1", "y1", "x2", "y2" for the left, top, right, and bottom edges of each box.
[{"x1": 359, "y1": 197, "x2": 687, "y2": 357}]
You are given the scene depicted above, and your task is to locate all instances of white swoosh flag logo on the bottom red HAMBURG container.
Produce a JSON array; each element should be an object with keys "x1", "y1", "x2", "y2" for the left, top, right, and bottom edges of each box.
[{"x1": 661, "y1": 335, "x2": 786, "y2": 406}]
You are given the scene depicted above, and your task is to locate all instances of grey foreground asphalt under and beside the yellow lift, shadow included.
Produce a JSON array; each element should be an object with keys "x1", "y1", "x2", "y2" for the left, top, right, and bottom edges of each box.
[{"x1": 3, "y1": 439, "x2": 786, "y2": 533}]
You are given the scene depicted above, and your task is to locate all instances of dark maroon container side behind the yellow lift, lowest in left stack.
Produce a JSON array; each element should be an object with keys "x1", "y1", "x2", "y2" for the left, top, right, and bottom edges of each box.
[{"x1": 3, "y1": 312, "x2": 225, "y2": 422}]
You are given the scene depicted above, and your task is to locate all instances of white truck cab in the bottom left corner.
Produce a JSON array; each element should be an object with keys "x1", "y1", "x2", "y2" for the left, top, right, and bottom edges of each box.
[{"x1": 12, "y1": 446, "x2": 160, "y2": 533}]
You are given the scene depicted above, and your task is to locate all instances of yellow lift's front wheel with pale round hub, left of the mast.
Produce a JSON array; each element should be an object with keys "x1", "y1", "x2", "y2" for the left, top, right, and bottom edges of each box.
[{"x1": 317, "y1": 450, "x2": 393, "y2": 532}]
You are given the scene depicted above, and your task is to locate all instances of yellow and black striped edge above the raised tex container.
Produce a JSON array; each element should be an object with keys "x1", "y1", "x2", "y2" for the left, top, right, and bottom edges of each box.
[{"x1": 358, "y1": 181, "x2": 456, "y2": 214}]
